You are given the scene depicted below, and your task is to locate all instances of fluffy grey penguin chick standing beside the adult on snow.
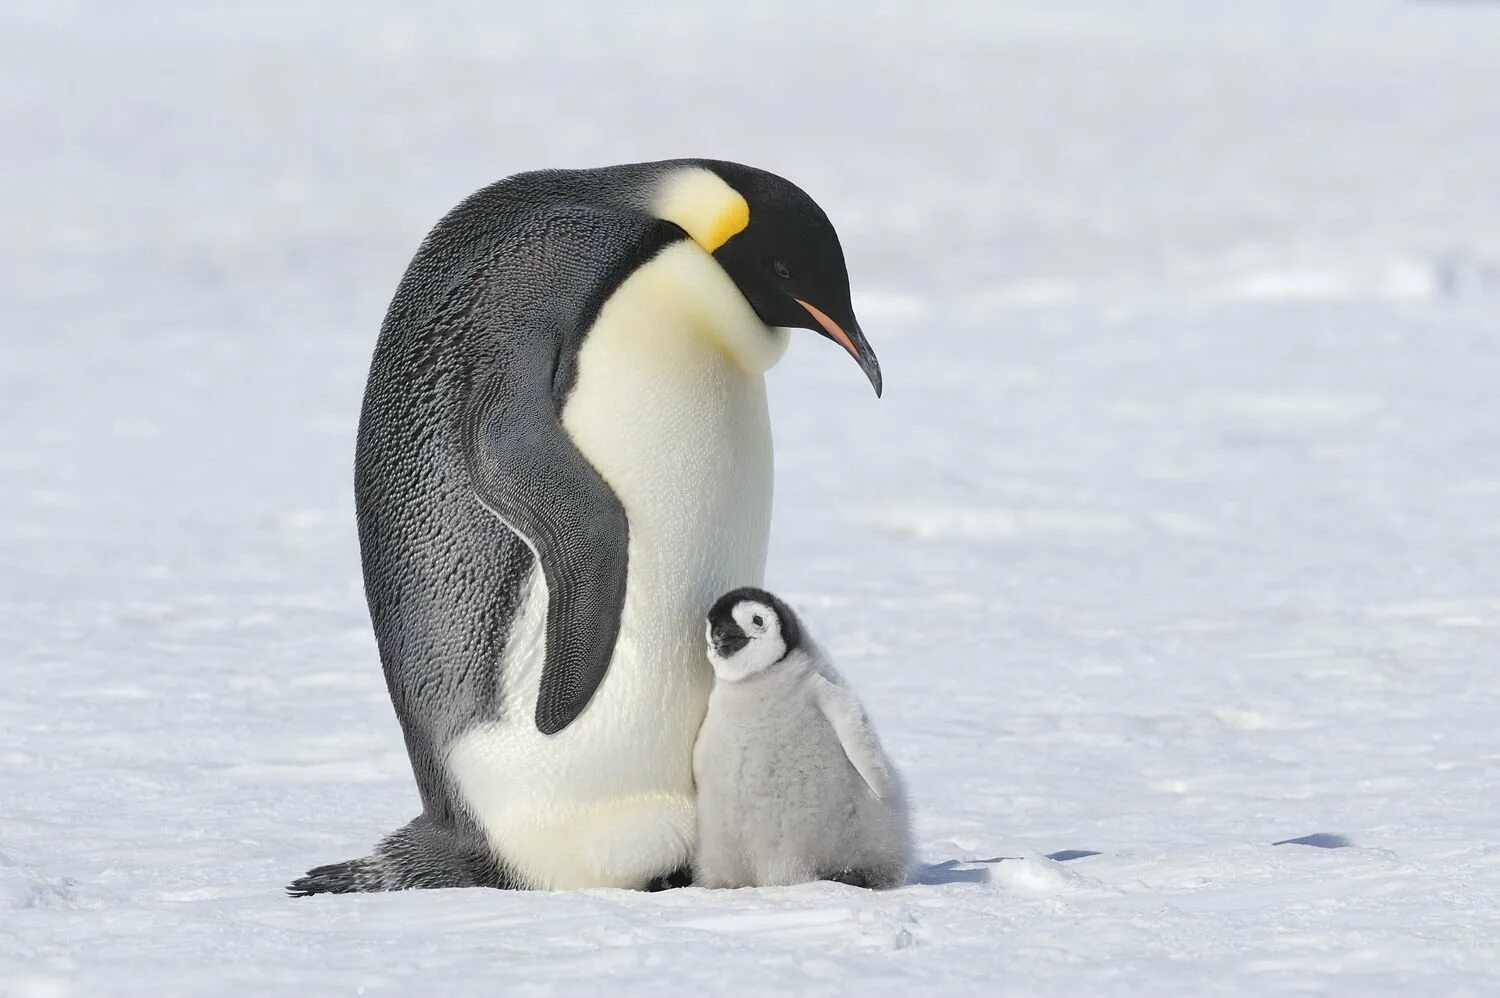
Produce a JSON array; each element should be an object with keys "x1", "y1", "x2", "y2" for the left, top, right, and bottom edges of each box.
[{"x1": 693, "y1": 588, "x2": 911, "y2": 888}]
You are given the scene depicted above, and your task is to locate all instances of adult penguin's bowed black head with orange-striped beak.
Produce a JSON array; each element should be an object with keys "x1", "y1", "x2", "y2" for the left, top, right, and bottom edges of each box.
[{"x1": 690, "y1": 161, "x2": 881, "y2": 396}]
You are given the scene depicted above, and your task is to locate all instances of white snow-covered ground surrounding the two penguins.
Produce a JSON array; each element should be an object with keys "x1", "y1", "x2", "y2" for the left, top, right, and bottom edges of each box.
[{"x1": 0, "y1": 2, "x2": 1500, "y2": 995}]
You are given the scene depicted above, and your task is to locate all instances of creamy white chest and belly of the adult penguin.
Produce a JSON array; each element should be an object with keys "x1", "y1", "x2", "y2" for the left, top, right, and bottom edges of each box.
[{"x1": 447, "y1": 240, "x2": 785, "y2": 888}]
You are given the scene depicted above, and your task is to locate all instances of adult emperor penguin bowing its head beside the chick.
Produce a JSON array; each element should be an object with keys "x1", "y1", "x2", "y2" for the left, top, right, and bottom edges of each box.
[{"x1": 290, "y1": 159, "x2": 881, "y2": 894}]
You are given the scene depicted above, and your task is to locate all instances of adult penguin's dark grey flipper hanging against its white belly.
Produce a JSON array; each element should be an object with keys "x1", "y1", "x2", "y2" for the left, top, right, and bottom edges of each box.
[{"x1": 464, "y1": 378, "x2": 630, "y2": 734}]
